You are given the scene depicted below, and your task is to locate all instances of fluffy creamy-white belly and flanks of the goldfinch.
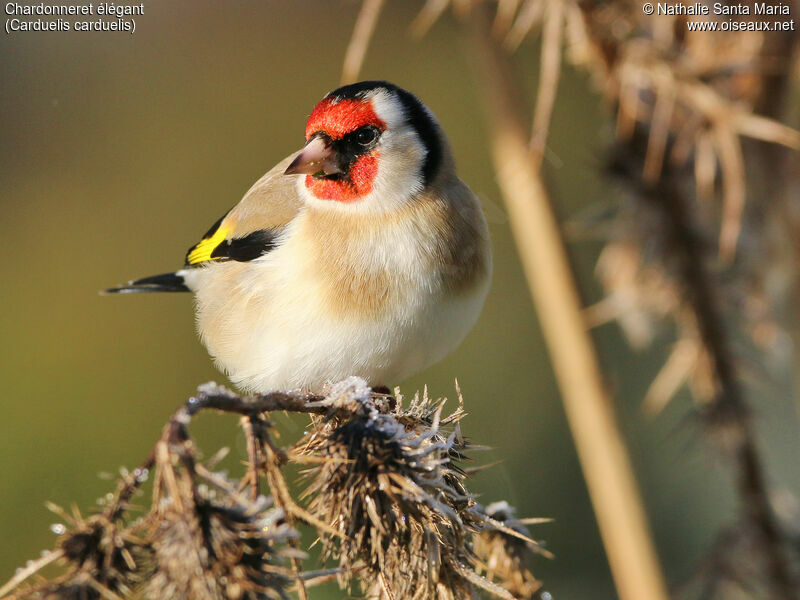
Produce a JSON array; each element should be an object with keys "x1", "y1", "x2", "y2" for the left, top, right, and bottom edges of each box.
[{"x1": 187, "y1": 227, "x2": 488, "y2": 393}]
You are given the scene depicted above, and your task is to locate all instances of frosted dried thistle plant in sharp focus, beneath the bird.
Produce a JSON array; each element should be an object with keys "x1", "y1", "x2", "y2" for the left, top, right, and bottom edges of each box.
[{"x1": 0, "y1": 378, "x2": 538, "y2": 600}]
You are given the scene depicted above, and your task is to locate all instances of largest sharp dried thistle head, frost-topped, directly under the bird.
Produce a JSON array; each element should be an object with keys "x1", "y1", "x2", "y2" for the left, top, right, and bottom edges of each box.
[{"x1": 293, "y1": 381, "x2": 510, "y2": 600}]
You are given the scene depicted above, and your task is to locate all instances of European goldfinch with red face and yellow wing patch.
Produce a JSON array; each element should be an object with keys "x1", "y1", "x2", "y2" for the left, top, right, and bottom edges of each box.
[{"x1": 108, "y1": 81, "x2": 492, "y2": 393}]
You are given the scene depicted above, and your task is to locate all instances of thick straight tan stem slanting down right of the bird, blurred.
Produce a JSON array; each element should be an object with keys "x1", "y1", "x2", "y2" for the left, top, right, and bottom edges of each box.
[{"x1": 473, "y1": 10, "x2": 667, "y2": 600}]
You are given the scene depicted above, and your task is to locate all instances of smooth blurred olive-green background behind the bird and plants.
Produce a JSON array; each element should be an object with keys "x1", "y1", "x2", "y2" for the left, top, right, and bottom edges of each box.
[{"x1": 0, "y1": 0, "x2": 800, "y2": 600}]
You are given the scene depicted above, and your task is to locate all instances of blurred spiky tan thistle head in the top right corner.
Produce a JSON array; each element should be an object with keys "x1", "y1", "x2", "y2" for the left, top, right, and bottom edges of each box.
[{"x1": 565, "y1": 0, "x2": 800, "y2": 264}]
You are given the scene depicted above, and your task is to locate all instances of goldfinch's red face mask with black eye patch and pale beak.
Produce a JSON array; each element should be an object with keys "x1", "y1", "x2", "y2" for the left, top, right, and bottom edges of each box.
[{"x1": 285, "y1": 98, "x2": 386, "y2": 202}]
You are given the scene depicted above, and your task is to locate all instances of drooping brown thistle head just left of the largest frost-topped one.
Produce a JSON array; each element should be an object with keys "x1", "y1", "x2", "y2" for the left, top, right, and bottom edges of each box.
[{"x1": 145, "y1": 428, "x2": 296, "y2": 600}]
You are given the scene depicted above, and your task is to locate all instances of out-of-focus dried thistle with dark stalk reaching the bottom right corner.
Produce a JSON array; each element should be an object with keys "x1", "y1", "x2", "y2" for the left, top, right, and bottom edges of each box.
[{"x1": 586, "y1": 3, "x2": 798, "y2": 598}]
